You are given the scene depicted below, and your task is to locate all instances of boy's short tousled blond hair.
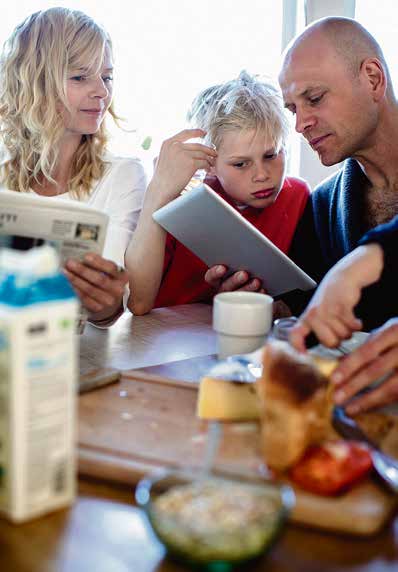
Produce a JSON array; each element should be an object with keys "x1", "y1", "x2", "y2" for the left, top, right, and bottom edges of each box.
[{"x1": 188, "y1": 71, "x2": 290, "y2": 150}]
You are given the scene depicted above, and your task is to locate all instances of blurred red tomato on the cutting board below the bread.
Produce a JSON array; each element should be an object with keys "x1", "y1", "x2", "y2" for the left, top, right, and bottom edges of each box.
[{"x1": 290, "y1": 441, "x2": 372, "y2": 495}]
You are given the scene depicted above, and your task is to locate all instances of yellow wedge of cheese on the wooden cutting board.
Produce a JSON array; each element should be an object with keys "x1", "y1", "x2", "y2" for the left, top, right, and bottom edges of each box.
[{"x1": 197, "y1": 377, "x2": 260, "y2": 421}]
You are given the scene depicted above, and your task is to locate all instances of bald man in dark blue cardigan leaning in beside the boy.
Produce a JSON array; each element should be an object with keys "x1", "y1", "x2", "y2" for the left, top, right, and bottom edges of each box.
[{"x1": 206, "y1": 18, "x2": 398, "y2": 329}]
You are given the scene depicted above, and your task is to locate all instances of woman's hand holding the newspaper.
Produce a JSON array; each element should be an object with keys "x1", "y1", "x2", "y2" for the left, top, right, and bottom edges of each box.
[{"x1": 64, "y1": 252, "x2": 128, "y2": 322}]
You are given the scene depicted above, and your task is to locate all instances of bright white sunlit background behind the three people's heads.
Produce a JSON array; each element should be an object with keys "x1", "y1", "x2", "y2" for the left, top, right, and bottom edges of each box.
[{"x1": 0, "y1": 0, "x2": 398, "y2": 179}]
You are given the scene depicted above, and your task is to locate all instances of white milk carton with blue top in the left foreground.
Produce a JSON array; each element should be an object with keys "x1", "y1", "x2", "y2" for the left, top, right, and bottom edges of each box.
[{"x1": 0, "y1": 246, "x2": 78, "y2": 522}]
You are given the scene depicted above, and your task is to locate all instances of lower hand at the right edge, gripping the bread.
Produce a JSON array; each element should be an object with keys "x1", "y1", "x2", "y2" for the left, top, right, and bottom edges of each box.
[{"x1": 331, "y1": 318, "x2": 398, "y2": 415}]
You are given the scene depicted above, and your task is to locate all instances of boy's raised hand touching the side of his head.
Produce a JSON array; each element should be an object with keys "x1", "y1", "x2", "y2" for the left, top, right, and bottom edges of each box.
[{"x1": 150, "y1": 129, "x2": 217, "y2": 206}]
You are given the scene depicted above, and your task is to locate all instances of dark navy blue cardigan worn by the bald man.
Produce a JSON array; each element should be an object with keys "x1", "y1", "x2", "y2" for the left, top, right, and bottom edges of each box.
[{"x1": 284, "y1": 159, "x2": 398, "y2": 330}]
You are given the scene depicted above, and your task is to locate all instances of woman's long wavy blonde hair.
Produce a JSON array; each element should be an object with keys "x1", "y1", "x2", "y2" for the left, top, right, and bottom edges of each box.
[{"x1": 0, "y1": 8, "x2": 117, "y2": 198}]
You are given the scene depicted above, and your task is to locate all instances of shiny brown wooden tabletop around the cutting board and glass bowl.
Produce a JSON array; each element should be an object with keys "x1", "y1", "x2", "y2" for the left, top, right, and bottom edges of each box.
[{"x1": 0, "y1": 306, "x2": 398, "y2": 572}]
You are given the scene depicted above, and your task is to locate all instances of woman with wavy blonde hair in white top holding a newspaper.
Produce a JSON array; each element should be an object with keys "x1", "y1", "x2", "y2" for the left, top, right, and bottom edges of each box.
[{"x1": 0, "y1": 8, "x2": 145, "y2": 326}]
